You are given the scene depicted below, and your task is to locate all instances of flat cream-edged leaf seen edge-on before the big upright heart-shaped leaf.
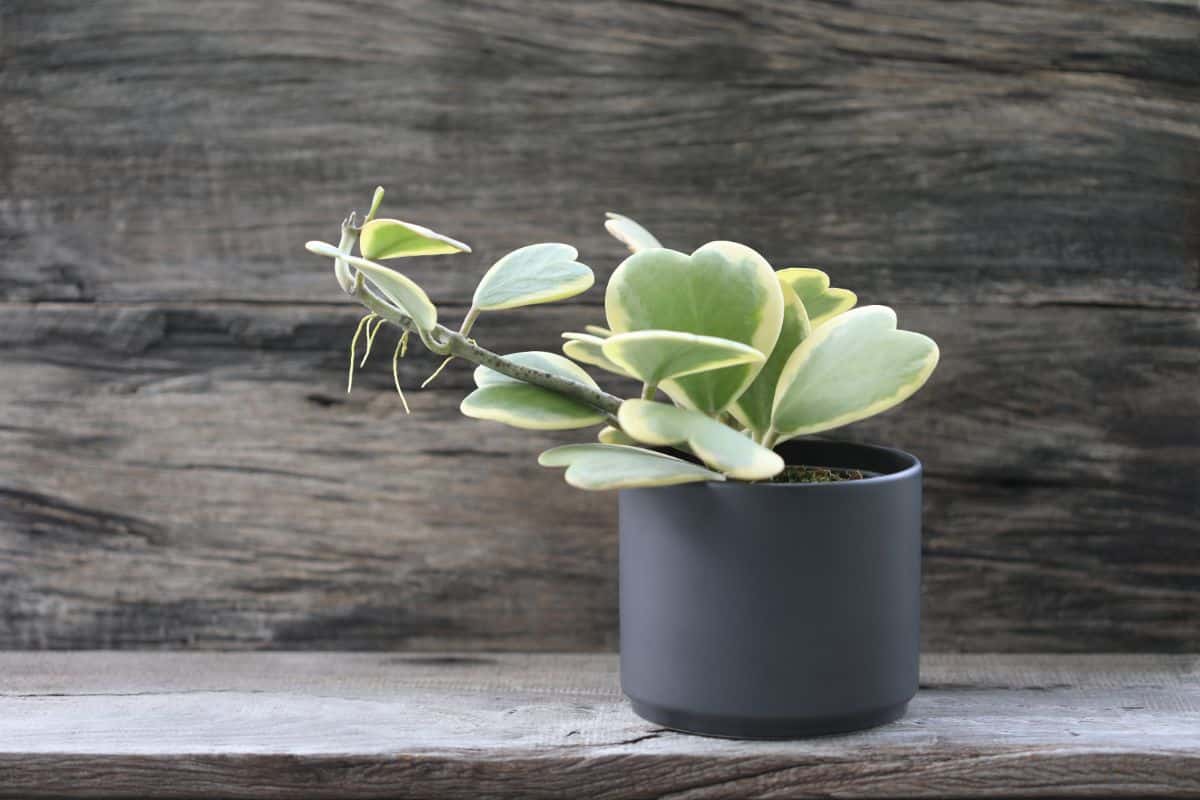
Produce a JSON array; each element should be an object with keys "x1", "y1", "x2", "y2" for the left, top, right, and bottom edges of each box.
[{"x1": 600, "y1": 331, "x2": 766, "y2": 386}]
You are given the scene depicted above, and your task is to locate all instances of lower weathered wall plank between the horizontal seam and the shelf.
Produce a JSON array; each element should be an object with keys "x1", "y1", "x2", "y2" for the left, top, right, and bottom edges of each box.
[{"x1": 0, "y1": 303, "x2": 1200, "y2": 651}]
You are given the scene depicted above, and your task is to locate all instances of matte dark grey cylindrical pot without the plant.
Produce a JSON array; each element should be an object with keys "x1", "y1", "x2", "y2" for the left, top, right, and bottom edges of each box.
[{"x1": 620, "y1": 440, "x2": 920, "y2": 738}]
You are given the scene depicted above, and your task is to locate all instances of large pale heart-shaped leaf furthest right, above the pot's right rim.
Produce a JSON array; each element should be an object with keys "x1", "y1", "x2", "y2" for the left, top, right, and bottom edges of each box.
[{"x1": 772, "y1": 306, "x2": 938, "y2": 441}]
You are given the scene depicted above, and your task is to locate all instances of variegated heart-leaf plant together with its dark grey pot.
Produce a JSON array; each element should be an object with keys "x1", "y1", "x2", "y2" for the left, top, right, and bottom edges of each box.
[{"x1": 307, "y1": 190, "x2": 938, "y2": 738}]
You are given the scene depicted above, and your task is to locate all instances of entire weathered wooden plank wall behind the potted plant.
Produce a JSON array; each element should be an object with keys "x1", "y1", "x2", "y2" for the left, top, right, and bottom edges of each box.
[{"x1": 0, "y1": 0, "x2": 1200, "y2": 651}]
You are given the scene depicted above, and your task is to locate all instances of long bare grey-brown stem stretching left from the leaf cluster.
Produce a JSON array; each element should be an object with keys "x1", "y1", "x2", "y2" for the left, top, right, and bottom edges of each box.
[{"x1": 350, "y1": 277, "x2": 620, "y2": 415}]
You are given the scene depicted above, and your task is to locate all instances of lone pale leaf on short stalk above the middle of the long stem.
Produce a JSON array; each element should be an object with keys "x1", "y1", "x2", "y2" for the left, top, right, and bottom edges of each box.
[{"x1": 473, "y1": 242, "x2": 596, "y2": 311}]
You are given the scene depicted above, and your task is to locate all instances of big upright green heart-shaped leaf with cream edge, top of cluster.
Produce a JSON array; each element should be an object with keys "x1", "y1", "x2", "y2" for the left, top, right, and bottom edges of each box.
[{"x1": 605, "y1": 241, "x2": 784, "y2": 414}]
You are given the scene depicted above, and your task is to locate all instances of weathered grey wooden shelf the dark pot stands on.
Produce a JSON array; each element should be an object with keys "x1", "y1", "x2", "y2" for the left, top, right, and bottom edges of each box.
[{"x1": 0, "y1": 652, "x2": 1200, "y2": 798}]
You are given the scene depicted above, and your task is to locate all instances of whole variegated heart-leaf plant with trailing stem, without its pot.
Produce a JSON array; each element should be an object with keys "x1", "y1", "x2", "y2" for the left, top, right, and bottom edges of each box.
[{"x1": 306, "y1": 188, "x2": 938, "y2": 489}]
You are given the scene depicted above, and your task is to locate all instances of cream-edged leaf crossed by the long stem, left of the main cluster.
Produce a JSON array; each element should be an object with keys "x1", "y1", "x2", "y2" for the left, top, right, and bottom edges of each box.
[{"x1": 460, "y1": 350, "x2": 605, "y2": 431}]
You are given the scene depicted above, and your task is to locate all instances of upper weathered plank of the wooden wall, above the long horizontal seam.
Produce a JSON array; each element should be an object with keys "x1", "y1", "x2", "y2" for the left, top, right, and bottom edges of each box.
[{"x1": 0, "y1": 0, "x2": 1200, "y2": 307}]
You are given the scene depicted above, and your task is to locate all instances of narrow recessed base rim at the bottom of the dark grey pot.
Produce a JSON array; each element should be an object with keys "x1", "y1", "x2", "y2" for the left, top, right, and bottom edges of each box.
[{"x1": 630, "y1": 699, "x2": 908, "y2": 739}]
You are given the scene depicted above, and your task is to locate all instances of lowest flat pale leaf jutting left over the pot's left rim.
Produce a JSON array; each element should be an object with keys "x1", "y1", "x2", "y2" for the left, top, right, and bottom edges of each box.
[{"x1": 538, "y1": 445, "x2": 725, "y2": 492}]
